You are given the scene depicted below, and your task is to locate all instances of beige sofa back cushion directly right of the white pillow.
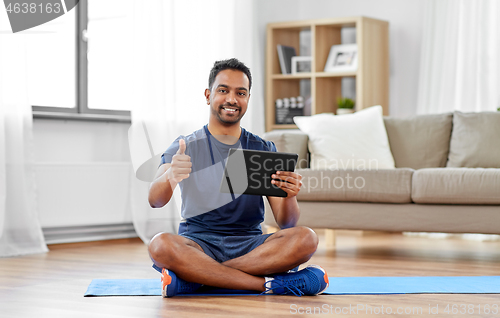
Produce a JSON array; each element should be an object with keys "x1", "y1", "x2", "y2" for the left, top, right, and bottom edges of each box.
[{"x1": 384, "y1": 113, "x2": 453, "y2": 169}]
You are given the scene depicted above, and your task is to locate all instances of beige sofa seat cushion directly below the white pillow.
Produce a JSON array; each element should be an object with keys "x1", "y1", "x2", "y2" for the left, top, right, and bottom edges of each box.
[{"x1": 297, "y1": 168, "x2": 414, "y2": 203}]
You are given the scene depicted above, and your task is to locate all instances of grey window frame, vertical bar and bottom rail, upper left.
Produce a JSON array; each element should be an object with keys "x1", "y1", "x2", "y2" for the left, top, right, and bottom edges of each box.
[{"x1": 31, "y1": 0, "x2": 131, "y2": 123}]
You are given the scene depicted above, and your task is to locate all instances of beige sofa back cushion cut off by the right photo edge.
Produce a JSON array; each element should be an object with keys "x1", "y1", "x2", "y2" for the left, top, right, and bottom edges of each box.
[{"x1": 447, "y1": 112, "x2": 500, "y2": 168}]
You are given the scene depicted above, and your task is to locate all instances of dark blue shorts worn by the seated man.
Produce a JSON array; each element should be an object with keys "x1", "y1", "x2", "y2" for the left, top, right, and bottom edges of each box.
[{"x1": 179, "y1": 232, "x2": 272, "y2": 263}]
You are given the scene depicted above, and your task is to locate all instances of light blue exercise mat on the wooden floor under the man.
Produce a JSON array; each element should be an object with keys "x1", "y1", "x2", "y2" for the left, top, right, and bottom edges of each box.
[{"x1": 84, "y1": 276, "x2": 500, "y2": 297}]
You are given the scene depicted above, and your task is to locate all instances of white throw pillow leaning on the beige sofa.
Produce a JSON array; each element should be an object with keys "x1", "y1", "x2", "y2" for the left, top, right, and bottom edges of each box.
[{"x1": 294, "y1": 106, "x2": 394, "y2": 170}]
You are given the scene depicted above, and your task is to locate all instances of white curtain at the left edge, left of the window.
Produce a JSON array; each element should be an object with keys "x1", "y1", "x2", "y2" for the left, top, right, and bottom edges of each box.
[{"x1": 0, "y1": 31, "x2": 47, "y2": 257}]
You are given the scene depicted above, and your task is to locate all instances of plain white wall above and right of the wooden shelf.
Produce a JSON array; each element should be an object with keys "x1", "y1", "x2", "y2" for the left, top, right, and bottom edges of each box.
[{"x1": 255, "y1": 0, "x2": 427, "y2": 117}]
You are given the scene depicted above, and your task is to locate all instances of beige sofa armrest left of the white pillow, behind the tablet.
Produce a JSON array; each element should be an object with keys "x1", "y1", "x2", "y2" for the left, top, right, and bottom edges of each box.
[{"x1": 264, "y1": 129, "x2": 309, "y2": 169}]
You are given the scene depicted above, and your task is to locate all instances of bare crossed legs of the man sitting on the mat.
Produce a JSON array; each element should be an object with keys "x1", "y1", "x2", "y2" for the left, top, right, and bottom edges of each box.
[{"x1": 149, "y1": 227, "x2": 318, "y2": 291}]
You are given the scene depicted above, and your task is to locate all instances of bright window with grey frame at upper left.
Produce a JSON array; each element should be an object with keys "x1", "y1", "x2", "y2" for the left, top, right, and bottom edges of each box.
[{"x1": 28, "y1": 0, "x2": 132, "y2": 122}]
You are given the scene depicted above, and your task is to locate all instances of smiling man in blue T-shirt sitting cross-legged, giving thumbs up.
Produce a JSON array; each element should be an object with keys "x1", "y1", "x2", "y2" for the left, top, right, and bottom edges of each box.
[{"x1": 149, "y1": 59, "x2": 328, "y2": 297}]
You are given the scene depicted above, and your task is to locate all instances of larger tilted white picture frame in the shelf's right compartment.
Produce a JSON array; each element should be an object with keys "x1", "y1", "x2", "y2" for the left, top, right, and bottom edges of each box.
[{"x1": 324, "y1": 44, "x2": 358, "y2": 73}]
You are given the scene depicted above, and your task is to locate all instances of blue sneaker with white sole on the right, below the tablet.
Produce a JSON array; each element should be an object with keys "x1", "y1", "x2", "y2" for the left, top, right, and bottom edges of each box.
[{"x1": 263, "y1": 265, "x2": 328, "y2": 297}]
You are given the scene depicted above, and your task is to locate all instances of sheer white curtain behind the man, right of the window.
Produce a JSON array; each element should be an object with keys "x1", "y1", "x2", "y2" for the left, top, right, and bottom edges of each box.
[{"x1": 129, "y1": 0, "x2": 264, "y2": 242}]
